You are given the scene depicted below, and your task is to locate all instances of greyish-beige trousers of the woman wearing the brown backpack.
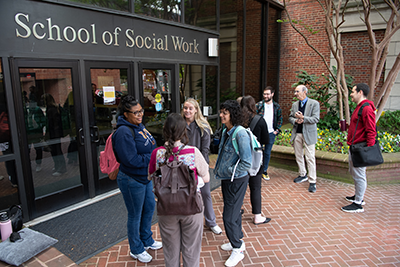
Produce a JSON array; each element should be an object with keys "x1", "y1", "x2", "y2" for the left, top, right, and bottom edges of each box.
[{"x1": 158, "y1": 212, "x2": 203, "y2": 267}]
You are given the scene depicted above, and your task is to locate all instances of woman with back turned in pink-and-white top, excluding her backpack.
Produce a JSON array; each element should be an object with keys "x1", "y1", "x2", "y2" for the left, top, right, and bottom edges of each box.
[{"x1": 149, "y1": 113, "x2": 210, "y2": 267}]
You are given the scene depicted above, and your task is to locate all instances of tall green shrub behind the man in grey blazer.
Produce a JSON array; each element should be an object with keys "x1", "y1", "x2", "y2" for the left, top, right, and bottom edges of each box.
[{"x1": 292, "y1": 66, "x2": 356, "y2": 130}]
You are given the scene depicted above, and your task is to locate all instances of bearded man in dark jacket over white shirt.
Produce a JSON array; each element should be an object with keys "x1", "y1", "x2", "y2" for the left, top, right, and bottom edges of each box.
[{"x1": 256, "y1": 86, "x2": 283, "y2": 181}]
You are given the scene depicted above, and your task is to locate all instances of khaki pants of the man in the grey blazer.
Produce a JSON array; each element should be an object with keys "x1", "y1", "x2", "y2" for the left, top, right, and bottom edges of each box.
[{"x1": 293, "y1": 133, "x2": 317, "y2": 183}]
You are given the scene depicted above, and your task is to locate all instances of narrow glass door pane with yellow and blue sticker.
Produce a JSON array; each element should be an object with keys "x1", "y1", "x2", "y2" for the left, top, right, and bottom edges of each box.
[{"x1": 142, "y1": 69, "x2": 172, "y2": 146}]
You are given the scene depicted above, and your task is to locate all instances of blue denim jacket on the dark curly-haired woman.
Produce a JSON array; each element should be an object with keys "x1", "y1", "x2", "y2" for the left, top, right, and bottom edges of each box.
[{"x1": 214, "y1": 126, "x2": 251, "y2": 180}]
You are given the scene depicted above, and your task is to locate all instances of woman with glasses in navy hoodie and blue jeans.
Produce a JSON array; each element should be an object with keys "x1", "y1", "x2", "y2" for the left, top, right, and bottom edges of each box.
[{"x1": 112, "y1": 95, "x2": 162, "y2": 263}]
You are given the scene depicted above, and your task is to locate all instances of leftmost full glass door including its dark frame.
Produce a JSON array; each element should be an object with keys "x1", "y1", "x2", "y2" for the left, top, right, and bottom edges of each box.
[{"x1": 13, "y1": 60, "x2": 88, "y2": 217}]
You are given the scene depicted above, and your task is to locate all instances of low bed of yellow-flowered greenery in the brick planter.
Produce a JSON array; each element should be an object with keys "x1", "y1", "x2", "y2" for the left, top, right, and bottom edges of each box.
[{"x1": 275, "y1": 128, "x2": 400, "y2": 154}]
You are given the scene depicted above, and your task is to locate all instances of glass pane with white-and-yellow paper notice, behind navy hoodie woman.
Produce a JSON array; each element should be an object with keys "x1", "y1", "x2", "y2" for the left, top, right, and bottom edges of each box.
[{"x1": 90, "y1": 68, "x2": 128, "y2": 181}]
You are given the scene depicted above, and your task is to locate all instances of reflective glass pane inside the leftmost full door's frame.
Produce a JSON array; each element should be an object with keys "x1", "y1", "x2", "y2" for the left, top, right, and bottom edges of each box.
[{"x1": 19, "y1": 68, "x2": 81, "y2": 198}]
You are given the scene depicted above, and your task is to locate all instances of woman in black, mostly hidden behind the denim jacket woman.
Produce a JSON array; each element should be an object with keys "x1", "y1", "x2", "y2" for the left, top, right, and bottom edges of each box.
[{"x1": 240, "y1": 95, "x2": 271, "y2": 225}]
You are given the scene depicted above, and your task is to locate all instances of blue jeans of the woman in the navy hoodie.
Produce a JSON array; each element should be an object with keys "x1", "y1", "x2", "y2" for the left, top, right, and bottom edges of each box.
[{"x1": 117, "y1": 171, "x2": 155, "y2": 254}]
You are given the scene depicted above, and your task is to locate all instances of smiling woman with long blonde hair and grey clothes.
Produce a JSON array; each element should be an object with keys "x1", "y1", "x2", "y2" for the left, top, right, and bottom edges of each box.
[{"x1": 181, "y1": 98, "x2": 222, "y2": 235}]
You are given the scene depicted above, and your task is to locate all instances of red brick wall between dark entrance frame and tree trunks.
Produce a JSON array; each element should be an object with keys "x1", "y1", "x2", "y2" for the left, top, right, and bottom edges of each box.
[{"x1": 279, "y1": 0, "x2": 330, "y2": 123}]
